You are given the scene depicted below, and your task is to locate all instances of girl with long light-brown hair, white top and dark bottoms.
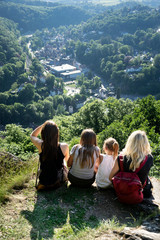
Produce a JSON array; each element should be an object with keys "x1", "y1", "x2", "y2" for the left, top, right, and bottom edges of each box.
[{"x1": 67, "y1": 129, "x2": 99, "y2": 187}]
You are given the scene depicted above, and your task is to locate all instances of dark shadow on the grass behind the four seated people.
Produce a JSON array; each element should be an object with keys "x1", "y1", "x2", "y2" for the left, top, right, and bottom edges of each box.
[{"x1": 21, "y1": 185, "x2": 159, "y2": 240}]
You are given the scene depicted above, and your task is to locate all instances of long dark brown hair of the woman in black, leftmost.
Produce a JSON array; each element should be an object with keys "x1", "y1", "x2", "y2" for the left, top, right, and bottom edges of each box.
[{"x1": 41, "y1": 121, "x2": 59, "y2": 161}]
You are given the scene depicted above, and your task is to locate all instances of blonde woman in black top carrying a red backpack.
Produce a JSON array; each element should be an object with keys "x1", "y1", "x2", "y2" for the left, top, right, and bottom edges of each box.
[{"x1": 109, "y1": 130, "x2": 153, "y2": 197}]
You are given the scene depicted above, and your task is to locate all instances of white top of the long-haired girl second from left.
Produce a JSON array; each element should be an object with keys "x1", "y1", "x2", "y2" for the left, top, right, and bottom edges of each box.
[{"x1": 70, "y1": 145, "x2": 99, "y2": 179}]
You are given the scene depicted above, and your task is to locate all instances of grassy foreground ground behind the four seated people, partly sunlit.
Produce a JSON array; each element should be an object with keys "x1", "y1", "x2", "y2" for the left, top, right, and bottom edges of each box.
[{"x1": 0, "y1": 175, "x2": 157, "y2": 240}]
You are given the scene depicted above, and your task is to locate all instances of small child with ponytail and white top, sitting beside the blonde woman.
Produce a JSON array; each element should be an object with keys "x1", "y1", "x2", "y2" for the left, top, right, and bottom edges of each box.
[{"x1": 95, "y1": 138, "x2": 119, "y2": 189}]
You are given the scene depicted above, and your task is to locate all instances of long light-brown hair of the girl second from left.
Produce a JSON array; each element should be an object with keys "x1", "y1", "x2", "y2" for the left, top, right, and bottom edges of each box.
[{"x1": 77, "y1": 129, "x2": 98, "y2": 168}]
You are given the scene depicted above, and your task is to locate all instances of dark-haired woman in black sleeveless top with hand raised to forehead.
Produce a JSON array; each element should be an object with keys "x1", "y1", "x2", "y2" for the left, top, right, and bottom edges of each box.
[{"x1": 31, "y1": 120, "x2": 69, "y2": 190}]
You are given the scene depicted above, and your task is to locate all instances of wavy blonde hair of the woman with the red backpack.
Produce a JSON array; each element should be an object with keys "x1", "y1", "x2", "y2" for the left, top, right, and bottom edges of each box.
[{"x1": 122, "y1": 130, "x2": 151, "y2": 171}]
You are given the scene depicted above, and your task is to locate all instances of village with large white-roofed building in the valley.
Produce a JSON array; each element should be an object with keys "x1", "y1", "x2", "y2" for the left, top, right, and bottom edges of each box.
[{"x1": 24, "y1": 30, "x2": 116, "y2": 114}]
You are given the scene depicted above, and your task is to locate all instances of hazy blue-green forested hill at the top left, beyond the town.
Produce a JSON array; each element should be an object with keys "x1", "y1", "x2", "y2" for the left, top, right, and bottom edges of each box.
[{"x1": 0, "y1": 1, "x2": 90, "y2": 32}]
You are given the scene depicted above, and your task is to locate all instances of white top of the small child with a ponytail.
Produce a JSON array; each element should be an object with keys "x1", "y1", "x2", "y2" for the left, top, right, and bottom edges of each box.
[{"x1": 96, "y1": 154, "x2": 115, "y2": 188}]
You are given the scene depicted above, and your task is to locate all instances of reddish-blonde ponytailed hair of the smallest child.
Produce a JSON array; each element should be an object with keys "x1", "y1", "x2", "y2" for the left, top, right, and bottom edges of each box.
[{"x1": 103, "y1": 137, "x2": 119, "y2": 159}]
